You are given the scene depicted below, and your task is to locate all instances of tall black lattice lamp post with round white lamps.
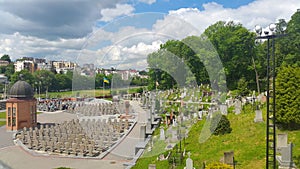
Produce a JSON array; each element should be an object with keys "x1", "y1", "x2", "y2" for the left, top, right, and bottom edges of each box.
[{"x1": 255, "y1": 22, "x2": 286, "y2": 169}]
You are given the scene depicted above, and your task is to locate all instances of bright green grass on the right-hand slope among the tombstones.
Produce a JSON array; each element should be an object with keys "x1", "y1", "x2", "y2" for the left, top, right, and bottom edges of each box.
[{"x1": 134, "y1": 105, "x2": 300, "y2": 169}]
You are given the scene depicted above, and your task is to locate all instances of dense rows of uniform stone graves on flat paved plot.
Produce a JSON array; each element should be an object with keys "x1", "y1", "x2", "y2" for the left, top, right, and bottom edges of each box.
[{"x1": 16, "y1": 99, "x2": 134, "y2": 158}]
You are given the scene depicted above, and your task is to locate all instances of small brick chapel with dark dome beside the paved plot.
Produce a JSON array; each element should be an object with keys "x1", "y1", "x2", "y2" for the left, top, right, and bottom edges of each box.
[{"x1": 6, "y1": 80, "x2": 37, "y2": 131}]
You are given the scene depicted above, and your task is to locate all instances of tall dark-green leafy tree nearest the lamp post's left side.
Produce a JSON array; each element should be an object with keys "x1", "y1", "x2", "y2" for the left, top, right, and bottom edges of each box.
[{"x1": 204, "y1": 21, "x2": 256, "y2": 90}]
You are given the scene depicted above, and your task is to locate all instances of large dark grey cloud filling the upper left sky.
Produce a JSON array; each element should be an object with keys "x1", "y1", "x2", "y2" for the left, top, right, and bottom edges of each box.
[{"x1": 0, "y1": 0, "x2": 122, "y2": 39}]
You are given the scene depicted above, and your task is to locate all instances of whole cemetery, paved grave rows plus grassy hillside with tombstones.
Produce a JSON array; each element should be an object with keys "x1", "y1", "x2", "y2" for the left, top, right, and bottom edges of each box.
[{"x1": 0, "y1": 79, "x2": 298, "y2": 169}]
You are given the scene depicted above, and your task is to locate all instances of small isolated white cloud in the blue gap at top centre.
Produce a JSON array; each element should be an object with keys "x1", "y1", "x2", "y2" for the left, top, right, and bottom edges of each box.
[{"x1": 100, "y1": 4, "x2": 134, "y2": 22}]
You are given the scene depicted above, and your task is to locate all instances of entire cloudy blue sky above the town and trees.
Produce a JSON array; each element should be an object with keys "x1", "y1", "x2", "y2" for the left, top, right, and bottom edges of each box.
[{"x1": 0, "y1": 0, "x2": 300, "y2": 70}]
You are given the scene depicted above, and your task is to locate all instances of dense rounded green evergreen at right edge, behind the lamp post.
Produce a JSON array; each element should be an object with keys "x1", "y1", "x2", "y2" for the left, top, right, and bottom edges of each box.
[{"x1": 276, "y1": 66, "x2": 300, "y2": 130}]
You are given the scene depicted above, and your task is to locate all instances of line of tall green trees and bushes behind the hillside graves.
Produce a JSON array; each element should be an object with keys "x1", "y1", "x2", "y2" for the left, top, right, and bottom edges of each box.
[{"x1": 147, "y1": 10, "x2": 300, "y2": 129}]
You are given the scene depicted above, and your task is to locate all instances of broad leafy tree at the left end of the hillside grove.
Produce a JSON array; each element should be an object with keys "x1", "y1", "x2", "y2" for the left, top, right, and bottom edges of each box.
[{"x1": 147, "y1": 37, "x2": 208, "y2": 90}]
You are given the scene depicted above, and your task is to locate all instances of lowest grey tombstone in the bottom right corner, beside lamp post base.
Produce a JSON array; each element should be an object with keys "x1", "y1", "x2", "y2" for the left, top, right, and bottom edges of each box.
[{"x1": 276, "y1": 143, "x2": 296, "y2": 169}]
